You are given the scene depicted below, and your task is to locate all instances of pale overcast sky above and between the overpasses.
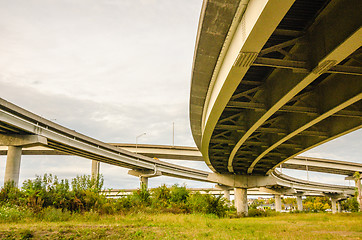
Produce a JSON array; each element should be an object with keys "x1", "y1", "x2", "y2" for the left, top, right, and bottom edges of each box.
[{"x1": 0, "y1": 0, "x2": 362, "y2": 191}]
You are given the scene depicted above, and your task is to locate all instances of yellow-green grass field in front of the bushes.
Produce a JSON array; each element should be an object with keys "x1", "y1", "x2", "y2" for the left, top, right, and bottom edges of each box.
[{"x1": 0, "y1": 213, "x2": 362, "y2": 240}]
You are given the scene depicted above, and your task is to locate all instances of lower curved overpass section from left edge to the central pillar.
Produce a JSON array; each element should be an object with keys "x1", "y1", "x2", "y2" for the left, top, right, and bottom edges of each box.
[{"x1": 0, "y1": 98, "x2": 208, "y2": 184}]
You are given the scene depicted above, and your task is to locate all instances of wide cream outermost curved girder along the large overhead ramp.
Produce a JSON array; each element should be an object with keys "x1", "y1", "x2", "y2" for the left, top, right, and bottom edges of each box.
[{"x1": 198, "y1": 0, "x2": 294, "y2": 170}]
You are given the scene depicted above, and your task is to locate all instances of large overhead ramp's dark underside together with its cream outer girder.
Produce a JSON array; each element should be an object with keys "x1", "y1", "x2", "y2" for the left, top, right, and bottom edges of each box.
[{"x1": 189, "y1": 0, "x2": 362, "y2": 174}]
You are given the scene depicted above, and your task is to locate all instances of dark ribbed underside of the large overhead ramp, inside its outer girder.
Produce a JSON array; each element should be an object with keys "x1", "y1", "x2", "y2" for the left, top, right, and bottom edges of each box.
[{"x1": 209, "y1": 0, "x2": 362, "y2": 174}]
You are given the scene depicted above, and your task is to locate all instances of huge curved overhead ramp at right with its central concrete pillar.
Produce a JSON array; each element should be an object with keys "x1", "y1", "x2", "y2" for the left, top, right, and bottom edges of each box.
[{"x1": 190, "y1": 0, "x2": 362, "y2": 214}]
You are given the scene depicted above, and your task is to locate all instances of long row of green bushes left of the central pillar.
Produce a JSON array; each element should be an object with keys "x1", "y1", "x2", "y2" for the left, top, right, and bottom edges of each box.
[{"x1": 0, "y1": 174, "x2": 230, "y2": 218}]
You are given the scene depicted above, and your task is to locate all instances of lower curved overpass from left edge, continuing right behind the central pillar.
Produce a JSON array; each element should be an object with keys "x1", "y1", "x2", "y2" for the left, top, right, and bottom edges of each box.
[{"x1": 0, "y1": 96, "x2": 354, "y2": 213}]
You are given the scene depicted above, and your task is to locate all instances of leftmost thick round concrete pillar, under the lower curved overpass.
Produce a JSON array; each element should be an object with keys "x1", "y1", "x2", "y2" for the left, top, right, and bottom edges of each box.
[{"x1": 4, "y1": 146, "x2": 22, "y2": 186}]
